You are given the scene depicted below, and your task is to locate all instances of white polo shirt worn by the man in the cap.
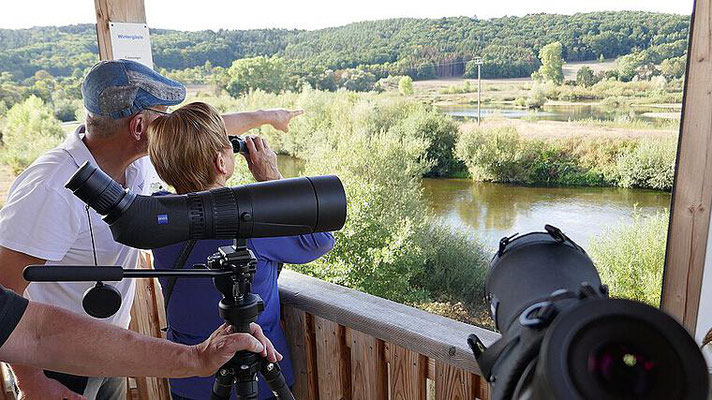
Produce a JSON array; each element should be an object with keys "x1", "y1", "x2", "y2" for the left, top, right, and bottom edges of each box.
[{"x1": 0, "y1": 126, "x2": 150, "y2": 328}]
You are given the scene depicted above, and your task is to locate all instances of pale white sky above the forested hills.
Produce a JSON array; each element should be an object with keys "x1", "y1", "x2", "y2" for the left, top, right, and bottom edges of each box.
[{"x1": 0, "y1": 0, "x2": 693, "y2": 30}]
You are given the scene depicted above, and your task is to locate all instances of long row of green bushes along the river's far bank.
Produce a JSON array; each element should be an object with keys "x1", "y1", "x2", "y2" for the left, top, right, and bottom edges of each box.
[{"x1": 455, "y1": 121, "x2": 677, "y2": 191}]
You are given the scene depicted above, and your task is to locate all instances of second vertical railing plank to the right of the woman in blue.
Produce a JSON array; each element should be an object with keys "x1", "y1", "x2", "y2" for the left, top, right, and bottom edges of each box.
[{"x1": 314, "y1": 317, "x2": 351, "y2": 400}]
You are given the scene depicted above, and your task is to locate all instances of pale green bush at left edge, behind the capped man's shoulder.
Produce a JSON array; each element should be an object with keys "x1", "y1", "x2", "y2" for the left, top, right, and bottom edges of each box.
[{"x1": 2, "y1": 96, "x2": 65, "y2": 174}]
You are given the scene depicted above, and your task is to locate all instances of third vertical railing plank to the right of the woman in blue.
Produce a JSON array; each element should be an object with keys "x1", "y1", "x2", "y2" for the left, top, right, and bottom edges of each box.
[{"x1": 346, "y1": 329, "x2": 388, "y2": 400}]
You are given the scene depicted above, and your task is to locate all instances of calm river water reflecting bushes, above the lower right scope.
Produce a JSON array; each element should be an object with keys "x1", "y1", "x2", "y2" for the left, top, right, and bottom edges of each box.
[{"x1": 423, "y1": 179, "x2": 670, "y2": 246}]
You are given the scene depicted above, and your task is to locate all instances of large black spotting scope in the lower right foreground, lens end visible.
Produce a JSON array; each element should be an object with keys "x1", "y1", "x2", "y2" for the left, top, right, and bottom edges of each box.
[{"x1": 468, "y1": 225, "x2": 708, "y2": 400}]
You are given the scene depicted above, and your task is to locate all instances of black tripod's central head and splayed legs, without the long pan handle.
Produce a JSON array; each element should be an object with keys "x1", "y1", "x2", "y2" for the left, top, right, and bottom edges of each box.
[{"x1": 208, "y1": 239, "x2": 294, "y2": 400}]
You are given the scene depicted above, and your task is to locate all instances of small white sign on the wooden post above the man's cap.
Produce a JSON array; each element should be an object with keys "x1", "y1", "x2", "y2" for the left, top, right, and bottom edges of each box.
[{"x1": 109, "y1": 22, "x2": 153, "y2": 69}]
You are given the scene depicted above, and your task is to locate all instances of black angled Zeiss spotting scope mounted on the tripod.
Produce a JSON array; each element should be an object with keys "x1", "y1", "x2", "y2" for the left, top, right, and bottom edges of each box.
[{"x1": 65, "y1": 162, "x2": 346, "y2": 249}]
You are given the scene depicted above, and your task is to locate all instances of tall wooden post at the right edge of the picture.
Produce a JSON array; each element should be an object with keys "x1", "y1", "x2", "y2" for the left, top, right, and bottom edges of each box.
[{"x1": 661, "y1": 0, "x2": 712, "y2": 335}]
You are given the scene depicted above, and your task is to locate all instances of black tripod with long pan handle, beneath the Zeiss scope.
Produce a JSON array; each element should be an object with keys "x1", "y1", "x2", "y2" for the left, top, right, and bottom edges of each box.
[{"x1": 23, "y1": 239, "x2": 295, "y2": 400}]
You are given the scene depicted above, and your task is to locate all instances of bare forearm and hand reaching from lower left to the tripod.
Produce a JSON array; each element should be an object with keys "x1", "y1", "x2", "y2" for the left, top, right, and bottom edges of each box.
[{"x1": 0, "y1": 296, "x2": 282, "y2": 378}]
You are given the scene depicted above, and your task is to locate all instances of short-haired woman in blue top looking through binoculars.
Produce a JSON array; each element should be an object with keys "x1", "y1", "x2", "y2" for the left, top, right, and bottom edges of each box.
[{"x1": 148, "y1": 103, "x2": 334, "y2": 399}]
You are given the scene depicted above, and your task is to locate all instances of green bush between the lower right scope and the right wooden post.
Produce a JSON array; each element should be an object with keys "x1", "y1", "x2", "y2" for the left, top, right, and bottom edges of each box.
[{"x1": 589, "y1": 211, "x2": 670, "y2": 307}]
